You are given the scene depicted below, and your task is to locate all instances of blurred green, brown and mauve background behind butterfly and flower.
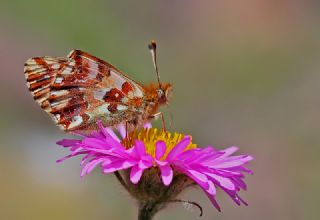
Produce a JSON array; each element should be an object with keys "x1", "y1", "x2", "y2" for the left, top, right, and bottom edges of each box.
[{"x1": 0, "y1": 0, "x2": 320, "y2": 220}]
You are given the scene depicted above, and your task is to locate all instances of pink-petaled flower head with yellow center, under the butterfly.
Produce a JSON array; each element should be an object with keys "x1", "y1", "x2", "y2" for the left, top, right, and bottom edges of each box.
[{"x1": 57, "y1": 122, "x2": 253, "y2": 211}]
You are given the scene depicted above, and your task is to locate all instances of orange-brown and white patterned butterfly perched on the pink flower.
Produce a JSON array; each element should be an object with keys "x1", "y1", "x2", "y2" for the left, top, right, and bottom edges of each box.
[{"x1": 24, "y1": 41, "x2": 172, "y2": 132}]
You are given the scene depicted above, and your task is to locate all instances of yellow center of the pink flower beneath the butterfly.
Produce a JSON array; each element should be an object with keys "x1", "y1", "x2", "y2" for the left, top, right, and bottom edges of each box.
[{"x1": 122, "y1": 128, "x2": 197, "y2": 159}]
